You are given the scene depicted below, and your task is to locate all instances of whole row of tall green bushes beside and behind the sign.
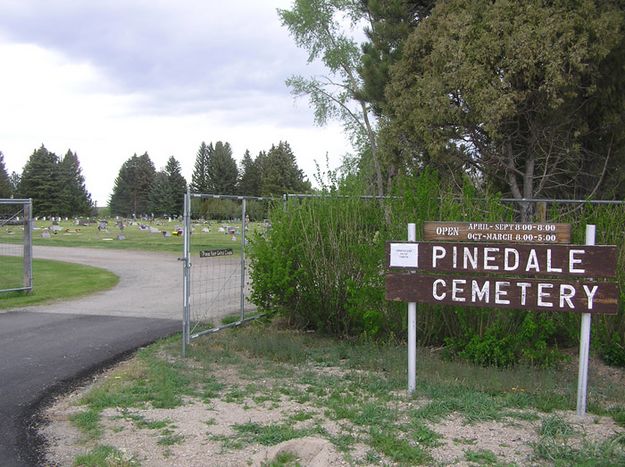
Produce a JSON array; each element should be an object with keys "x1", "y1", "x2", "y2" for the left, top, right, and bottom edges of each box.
[{"x1": 251, "y1": 171, "x2": 625, "y2": 366}]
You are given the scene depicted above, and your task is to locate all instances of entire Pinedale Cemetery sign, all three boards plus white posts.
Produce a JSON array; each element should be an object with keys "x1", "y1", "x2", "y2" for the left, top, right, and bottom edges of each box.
[{"x1": 386, "y1": 222, "x2": 619, "y2": 417}]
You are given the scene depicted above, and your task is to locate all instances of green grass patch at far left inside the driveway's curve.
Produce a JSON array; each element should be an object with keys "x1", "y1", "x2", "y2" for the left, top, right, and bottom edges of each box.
[{"x1": 0, "y1": 256, "x2": 119, "y2": 310}]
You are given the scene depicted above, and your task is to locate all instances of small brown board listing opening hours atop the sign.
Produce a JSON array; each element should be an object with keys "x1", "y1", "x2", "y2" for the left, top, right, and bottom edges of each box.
[{"x1": 423, "y1": 222, "x2": 571, "y2": 243}]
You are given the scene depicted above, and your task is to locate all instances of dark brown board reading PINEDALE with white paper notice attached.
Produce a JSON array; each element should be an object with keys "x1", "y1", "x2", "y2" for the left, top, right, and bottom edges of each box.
[{"x1": 387, "y1": 242, "x2": 617, "y2": 278}]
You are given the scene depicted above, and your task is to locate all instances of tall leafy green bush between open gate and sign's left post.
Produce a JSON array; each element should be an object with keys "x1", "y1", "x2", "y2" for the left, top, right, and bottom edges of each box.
[{"x1": 251, "y1": 197, "x2": 384, "y2": 335}]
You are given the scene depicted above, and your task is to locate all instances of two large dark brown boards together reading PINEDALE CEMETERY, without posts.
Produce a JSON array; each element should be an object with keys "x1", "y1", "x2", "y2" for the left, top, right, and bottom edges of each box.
[{"x1": 386, "y1": 236, "x2": 619, "y2": 314}]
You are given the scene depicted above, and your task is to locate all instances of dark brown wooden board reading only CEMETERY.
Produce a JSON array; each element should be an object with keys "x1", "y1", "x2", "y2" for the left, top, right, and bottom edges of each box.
[{"x1": 386, "y1": 273, "x2": 619, "y2": 314}]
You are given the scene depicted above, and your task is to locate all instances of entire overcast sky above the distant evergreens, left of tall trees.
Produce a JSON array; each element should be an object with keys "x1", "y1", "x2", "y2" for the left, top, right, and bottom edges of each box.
[{"x1": 0, "y1": 0, "x2": 351, "y2": 206}]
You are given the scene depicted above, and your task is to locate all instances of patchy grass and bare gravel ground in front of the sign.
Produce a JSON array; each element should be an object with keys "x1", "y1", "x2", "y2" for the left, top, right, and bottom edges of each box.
[{"x1": 57, "y1": 321, "x2": 625, "y2": 465}]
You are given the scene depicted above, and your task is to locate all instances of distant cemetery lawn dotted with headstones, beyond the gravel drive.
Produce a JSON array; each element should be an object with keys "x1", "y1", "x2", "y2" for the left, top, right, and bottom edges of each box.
[{"x1": 0, "y1": 220, "x2": 263, "y2": 254}]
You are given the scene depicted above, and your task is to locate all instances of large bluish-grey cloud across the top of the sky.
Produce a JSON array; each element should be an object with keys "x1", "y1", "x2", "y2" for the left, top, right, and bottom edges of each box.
[{"x1": 0, "y1": 0, "x2": 316, "y2": 117}]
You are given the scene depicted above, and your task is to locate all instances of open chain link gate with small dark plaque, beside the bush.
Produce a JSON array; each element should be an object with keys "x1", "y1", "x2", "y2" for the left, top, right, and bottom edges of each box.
[{"x1": 181, "y1": 192, "x2": 273, "y2": 355}]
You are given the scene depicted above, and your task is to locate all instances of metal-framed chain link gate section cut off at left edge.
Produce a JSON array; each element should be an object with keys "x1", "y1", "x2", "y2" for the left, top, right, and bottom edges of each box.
[{"x1": 0, "y1": 199, "x2": 33, "y2": 292}]
